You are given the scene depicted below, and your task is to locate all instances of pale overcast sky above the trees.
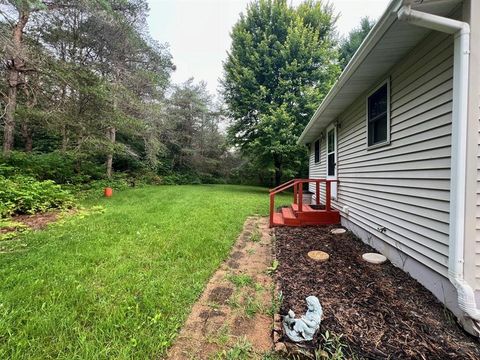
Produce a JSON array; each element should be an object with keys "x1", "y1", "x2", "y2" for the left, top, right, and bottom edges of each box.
[{"x1": 145, "y1": 0, "x2": 389, "y2": 93}]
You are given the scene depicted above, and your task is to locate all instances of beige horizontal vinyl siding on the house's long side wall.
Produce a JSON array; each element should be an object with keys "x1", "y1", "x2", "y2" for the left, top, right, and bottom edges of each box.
[{"x1": 328, "y1": 33, "x2": 456, "y2": 276}]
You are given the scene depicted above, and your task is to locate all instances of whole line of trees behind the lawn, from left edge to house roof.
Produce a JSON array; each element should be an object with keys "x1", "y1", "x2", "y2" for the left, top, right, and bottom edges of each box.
[{"x1": 0, "y1": 0, "x2": 371, "y2": 188}]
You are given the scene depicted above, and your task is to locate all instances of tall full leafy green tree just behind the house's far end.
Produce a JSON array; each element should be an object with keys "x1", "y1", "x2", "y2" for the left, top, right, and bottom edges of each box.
[{"x1": 222, "y1": 0, "x2": 339, "y2": 184}]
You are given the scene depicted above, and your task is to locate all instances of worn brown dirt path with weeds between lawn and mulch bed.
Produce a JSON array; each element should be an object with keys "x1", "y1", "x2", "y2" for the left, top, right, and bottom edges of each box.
[{"x1": 167, "y1": 217, "x2": 273, "y2": 359}]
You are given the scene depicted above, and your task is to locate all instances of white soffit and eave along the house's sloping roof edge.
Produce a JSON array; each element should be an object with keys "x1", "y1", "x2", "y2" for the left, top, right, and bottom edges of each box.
[{"x1": 298, "y1": 0, "x2": 464, "y2": 144}]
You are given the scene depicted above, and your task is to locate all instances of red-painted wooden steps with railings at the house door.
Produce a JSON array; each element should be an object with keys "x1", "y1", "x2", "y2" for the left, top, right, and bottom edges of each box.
[{"x1": 270, "y1": 179, "x2": 340, "y2": 227}]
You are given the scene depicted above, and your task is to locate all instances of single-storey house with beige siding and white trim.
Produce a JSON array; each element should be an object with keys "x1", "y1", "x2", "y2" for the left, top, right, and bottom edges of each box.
[{"x1": 272, "y1": 0, "x2": 480, "y2": 335}]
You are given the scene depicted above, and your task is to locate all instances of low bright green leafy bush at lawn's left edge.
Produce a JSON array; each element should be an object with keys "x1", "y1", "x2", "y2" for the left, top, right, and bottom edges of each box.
[{"x1": 0, "y1": 175, "x2": 74, "y2": 217}]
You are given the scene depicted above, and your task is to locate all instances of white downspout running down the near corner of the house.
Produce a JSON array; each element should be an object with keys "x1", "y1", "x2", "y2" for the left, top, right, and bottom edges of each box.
[{"x1": 397, "y1": 6, "x2": 480, "y2": 327}]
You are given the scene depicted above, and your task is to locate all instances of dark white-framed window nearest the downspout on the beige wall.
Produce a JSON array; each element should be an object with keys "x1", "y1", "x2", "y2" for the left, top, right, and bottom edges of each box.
[{"x1": 367, "y1": 81, "x2": 390, "y2": 146}]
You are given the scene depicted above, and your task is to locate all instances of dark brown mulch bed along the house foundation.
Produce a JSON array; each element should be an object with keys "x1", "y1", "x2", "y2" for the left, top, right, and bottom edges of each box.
[{"x1": 275, "y1": 227, "x2": 480, "y2": 359}]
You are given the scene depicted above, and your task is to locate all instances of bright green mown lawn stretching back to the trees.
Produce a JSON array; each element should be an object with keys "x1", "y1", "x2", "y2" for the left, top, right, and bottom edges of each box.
[{"x1": 0, "y1": 185, "x2": 289, "y2": 359}]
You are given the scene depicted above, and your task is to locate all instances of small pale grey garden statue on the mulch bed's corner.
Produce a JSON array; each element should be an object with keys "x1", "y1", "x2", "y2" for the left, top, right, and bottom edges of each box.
[{"x1": 283, "y1": 296, "x2": 323, "y2": 342}]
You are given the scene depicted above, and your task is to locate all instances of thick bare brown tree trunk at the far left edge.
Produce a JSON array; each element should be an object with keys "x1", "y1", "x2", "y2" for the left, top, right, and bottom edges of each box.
[{"x1": 3, "y1": 10, "x2": 30, "y2": 154}]
